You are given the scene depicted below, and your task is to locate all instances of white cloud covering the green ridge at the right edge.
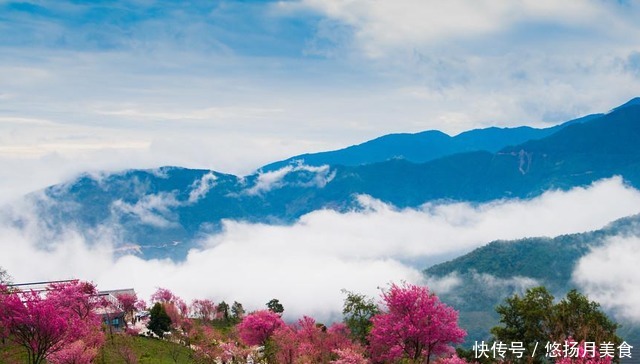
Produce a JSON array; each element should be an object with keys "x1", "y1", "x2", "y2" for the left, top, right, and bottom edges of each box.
[{"x1": 573, "y1": 236, "x2": 640, "y2": 323}]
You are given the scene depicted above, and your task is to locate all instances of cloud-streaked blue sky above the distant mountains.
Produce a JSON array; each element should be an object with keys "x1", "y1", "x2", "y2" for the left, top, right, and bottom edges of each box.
[{"x1": 0, "y1": 0, "x2": 640, "y2": 198}]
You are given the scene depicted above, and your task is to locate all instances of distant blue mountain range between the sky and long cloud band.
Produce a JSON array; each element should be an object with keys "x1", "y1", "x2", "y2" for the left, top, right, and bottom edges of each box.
[{"x1": 21, "y1": 99, "x2": 640, "y2": 260}]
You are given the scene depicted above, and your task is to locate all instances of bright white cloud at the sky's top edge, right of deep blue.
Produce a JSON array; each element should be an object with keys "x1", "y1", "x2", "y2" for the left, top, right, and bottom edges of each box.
[{"x1": 288, "y1": 0, "x2": 638, "y2": 57}]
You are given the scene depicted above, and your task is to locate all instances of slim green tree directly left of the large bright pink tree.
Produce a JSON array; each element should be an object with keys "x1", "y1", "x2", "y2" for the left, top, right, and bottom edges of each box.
[{"x1": 342, "y1": 289, "x2": 380, "y2": 345}]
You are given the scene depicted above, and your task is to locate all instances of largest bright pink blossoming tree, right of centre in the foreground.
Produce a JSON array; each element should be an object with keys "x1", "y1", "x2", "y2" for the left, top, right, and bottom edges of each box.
[{"x1": 369, "y1": 284, "x2": 466, "y2": 363}]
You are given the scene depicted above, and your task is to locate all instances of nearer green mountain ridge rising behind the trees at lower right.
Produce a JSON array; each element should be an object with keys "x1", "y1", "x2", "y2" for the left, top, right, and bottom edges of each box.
[{"x1": 424, "y1": 214, "x2": 640, "y2": 344}]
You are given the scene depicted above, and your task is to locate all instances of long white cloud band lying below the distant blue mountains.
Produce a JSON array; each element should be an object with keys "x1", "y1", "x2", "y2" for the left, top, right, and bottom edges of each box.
[{"x1": 0, "y1": 178, "x2": 640, "y2": 320}]
